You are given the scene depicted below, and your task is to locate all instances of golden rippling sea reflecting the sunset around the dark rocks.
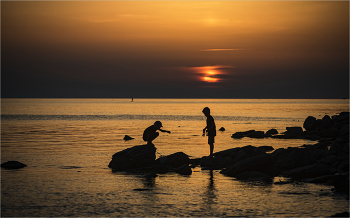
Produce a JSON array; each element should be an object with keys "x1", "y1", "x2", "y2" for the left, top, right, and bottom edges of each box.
[{"x1": 1, "y1": 98, "x2": 349, "y2": 217}]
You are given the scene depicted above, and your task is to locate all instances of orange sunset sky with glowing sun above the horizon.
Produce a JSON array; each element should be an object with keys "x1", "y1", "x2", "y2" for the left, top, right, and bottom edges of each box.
[{"x1": 1, "y1": 1, "x2": 349, "y2": 98}]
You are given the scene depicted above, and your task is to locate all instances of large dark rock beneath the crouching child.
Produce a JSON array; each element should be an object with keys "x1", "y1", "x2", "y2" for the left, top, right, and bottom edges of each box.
[{"x1": 108, "y1": 145, "x2": 156, "y2": 170}]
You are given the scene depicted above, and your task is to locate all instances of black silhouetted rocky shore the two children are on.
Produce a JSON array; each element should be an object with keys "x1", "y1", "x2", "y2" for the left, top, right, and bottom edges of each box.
[{"x1": 109, "y1": 112, "x2": 349, "y2": 195}]
